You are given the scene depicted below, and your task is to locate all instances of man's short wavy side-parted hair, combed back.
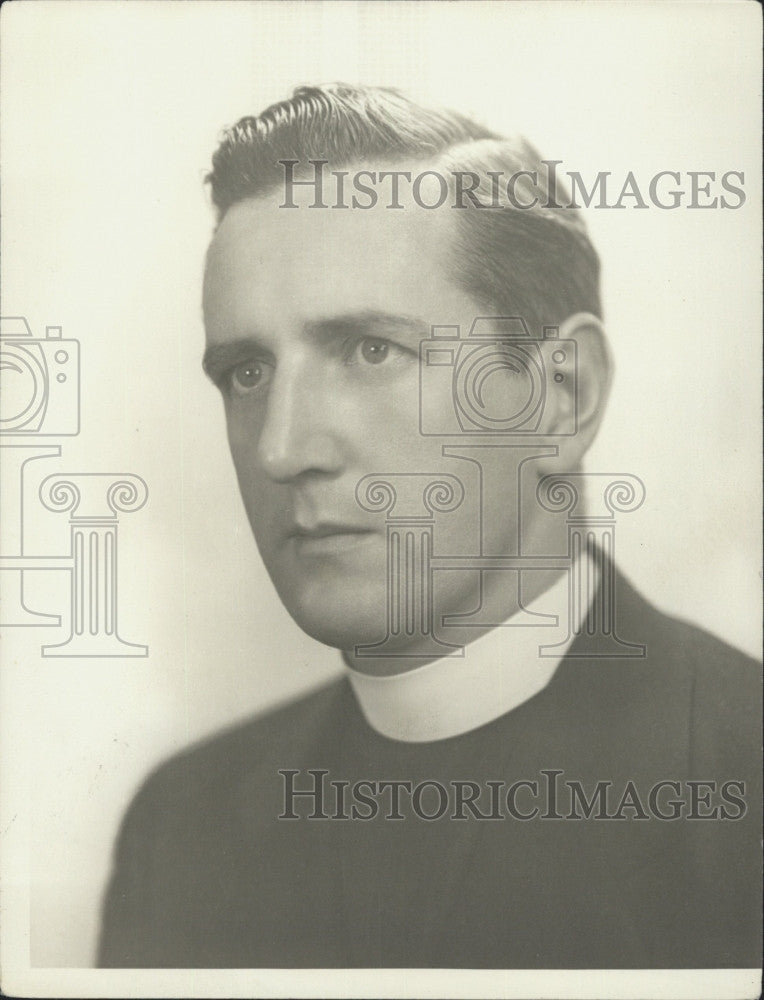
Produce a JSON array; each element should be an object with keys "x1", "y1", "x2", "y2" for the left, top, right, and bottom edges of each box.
[{"x1": 206, "y1": 84, "x2": 601, "y2": 324}]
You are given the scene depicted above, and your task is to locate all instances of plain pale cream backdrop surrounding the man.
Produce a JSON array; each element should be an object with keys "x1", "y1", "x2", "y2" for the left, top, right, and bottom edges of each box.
[{"x1": 0, "y1": 2, "x2": 760, "y2": 995}]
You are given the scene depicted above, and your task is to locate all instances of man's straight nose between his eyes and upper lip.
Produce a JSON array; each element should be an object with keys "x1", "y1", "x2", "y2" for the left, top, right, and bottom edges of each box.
[{"x1": 257, "y1": 364, "x2": 343, "y2": 482}]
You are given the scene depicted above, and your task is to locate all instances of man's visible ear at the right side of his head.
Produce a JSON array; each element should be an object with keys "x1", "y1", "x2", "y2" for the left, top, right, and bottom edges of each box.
[{"x1": 536, "y1": 312, "x2": 613, "y2": 474}]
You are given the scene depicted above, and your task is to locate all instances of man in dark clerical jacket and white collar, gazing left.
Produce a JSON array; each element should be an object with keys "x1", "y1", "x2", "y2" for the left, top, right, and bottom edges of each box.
[{"x1": 99, "y1": 86, "x2": 759, "y2": 968}]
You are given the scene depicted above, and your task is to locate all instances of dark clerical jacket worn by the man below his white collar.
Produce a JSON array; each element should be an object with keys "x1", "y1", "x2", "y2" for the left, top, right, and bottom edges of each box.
[{"x1": 99, "y1": 577, "x2": 761, "y2": 969}]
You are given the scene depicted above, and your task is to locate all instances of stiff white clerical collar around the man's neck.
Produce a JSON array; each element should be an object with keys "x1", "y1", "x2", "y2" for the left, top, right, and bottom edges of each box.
[{"x1": 346, "y1": 553, "x2": 599, "y2": 743}]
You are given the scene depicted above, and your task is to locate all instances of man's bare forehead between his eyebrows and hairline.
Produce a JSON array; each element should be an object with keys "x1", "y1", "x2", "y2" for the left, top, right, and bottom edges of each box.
[{"x1": 203, "y1": 164, "x2": 490, "y2": 341}]
